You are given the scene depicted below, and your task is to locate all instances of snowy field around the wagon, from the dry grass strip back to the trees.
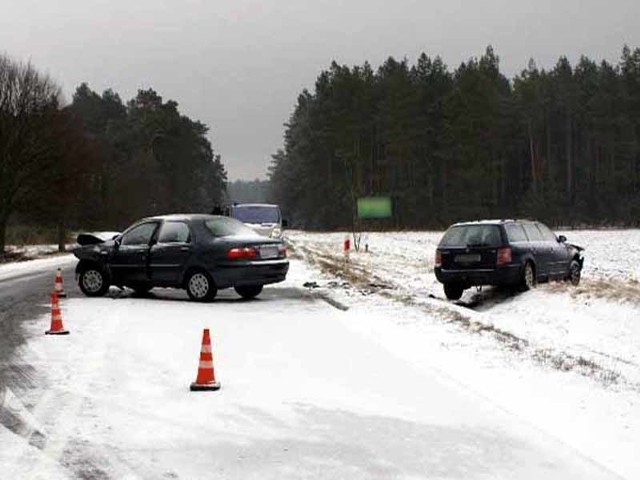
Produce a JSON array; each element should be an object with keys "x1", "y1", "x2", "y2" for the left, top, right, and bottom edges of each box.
[{"x1": 289, "y1": 230, "x2": 640, "y2": 391}]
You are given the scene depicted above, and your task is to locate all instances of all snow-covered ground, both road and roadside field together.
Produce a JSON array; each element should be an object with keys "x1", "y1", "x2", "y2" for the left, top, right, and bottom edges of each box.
[{"x1": 0, "y1": 231, "x2": 640, "y2": 480}]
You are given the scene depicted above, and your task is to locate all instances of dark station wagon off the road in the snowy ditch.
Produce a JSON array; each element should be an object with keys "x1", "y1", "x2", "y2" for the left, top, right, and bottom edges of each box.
[{"x1": 435, "y1": 220, "x2": 584, "y2": 300}]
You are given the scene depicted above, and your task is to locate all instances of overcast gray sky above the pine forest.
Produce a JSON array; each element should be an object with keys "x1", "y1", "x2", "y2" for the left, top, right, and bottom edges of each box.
[{"x1": 0, "y1": 0, "x2": 640, "y2": 180}]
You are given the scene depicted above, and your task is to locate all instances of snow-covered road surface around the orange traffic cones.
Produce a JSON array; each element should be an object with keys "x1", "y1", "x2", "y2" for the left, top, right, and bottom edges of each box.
[{"x1": 0, "y1": 253, "x2": 630, "y2": 480}]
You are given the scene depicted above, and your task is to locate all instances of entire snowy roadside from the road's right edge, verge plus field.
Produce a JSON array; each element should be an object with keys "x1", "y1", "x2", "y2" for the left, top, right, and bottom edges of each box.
[{"x1": 288, "y1": 230, "x2": 640, "y2": 478}]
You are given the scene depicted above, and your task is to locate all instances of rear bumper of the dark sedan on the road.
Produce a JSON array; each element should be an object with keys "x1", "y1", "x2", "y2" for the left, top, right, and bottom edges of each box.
[{"x1": 211, "y1": 260, "x2": 289, "y2": 288}]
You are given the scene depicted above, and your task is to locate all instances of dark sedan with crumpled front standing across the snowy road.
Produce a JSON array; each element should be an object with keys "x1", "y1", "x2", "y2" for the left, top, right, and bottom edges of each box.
[{"x1": 73, "y1": 214, "x2": 289, "y2": 301}]
